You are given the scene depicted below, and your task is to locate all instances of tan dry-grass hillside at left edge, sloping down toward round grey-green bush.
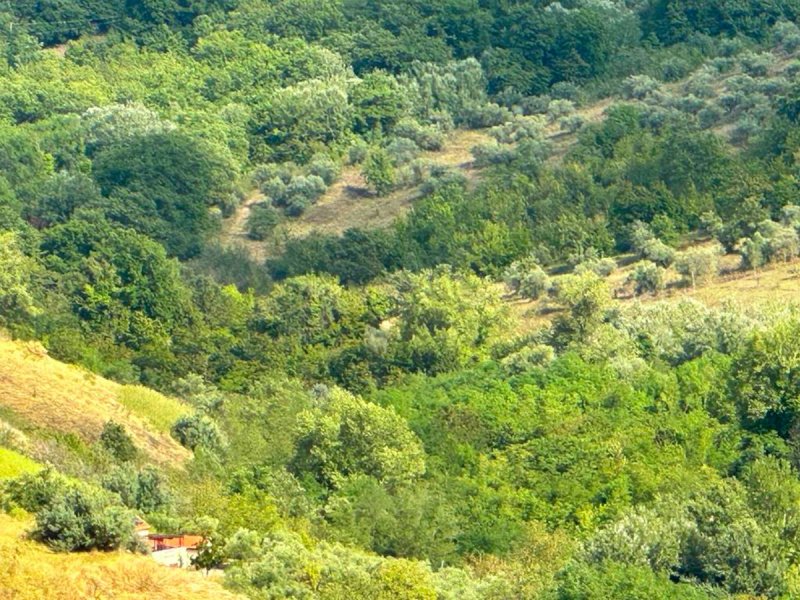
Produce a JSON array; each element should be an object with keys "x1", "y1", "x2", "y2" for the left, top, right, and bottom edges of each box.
[{"x1": 0, "y1": 339, "x2": 189, "y2": 465}]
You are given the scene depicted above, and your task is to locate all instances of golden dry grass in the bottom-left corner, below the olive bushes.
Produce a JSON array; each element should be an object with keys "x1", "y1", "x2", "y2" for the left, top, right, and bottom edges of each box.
[{"x1": 0, "y1": 514, "x2": 242, "y2": 600}]
